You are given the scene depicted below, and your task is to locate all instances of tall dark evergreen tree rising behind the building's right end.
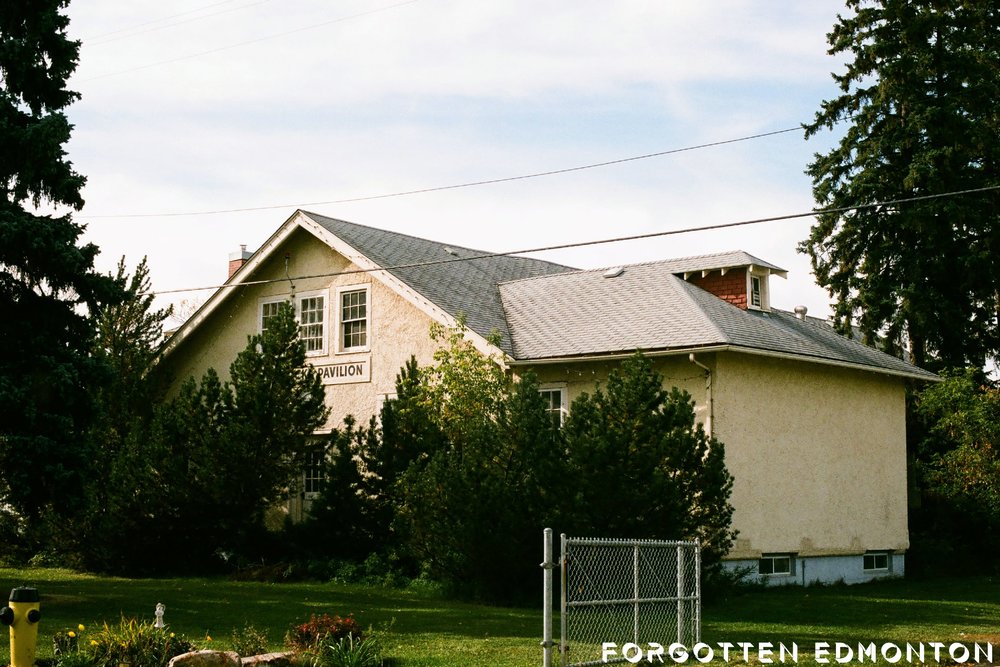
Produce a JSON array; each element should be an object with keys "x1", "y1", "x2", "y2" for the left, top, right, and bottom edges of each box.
[{"x1": 800, "y1": 0, "x2": 1000, "y2": 368}]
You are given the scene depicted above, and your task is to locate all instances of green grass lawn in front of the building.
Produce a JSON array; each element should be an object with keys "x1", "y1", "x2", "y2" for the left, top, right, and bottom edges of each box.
[{"x1": 0, "y1": 569, "x2": 1000, "y2": 667}]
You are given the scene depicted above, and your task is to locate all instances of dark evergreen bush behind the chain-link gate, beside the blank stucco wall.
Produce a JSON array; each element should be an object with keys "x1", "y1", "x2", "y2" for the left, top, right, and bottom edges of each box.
[{"x1": 564, "y1": 353, "x2": 735, "y2": 571}]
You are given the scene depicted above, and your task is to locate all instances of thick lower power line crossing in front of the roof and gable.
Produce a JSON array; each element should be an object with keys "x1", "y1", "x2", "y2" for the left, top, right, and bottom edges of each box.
[{"x1": 149, "y1": 185, "x2": 1000, "y2": 296}]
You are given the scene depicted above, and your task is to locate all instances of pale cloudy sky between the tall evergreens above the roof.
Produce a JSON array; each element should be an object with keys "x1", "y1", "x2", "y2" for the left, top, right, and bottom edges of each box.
[{"x1": 66, "y1": 0, "x2": 846, "y2": 324}]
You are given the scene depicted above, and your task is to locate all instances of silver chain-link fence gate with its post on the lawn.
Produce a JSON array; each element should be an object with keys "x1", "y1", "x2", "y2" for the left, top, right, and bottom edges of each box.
[{"x1": 542, "y1": 529, "x2": 701, "y2": 667}]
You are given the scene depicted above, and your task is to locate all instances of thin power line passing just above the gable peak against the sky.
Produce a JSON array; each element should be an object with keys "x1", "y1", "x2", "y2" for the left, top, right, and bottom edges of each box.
[{"x1": 82, "y1": 126, "x2": 802, "y2": 220}]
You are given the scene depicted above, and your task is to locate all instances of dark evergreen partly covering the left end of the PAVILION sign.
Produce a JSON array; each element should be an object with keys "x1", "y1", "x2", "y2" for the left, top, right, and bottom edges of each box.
[{"x1": 114, "y1": 303, "x2": 328, "y2": 572}]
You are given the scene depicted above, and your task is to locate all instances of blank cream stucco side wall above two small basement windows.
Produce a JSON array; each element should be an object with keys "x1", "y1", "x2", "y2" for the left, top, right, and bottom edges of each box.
[{"x1": 714, "y1": 353, "x2": 909, "y2": 559}]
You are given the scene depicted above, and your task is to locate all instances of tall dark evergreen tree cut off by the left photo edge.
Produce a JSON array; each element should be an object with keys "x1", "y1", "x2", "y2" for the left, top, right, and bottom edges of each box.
[{"x1": 0, "y1": 0, "x2": 115, "y2": 520}]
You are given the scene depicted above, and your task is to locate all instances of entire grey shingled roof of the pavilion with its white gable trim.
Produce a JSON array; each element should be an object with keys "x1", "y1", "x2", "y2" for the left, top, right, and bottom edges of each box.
[{"x1": 166, "y1": 211, "x2": 937, "y2": 380}]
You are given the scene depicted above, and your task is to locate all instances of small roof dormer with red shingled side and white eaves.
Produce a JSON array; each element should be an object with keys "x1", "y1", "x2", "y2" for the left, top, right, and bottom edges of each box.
[{"x1": 675, "y1": 251, "x2": 788, "y2": 311}]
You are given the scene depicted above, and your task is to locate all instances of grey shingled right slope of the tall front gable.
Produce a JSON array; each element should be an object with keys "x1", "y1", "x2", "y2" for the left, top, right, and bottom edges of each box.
[{"x1": 303, "y1": 211, "x2": 574, "y2": 354}]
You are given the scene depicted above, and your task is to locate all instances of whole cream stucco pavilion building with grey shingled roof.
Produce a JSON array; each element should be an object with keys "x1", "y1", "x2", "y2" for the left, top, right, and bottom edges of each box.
[{"x1": 165, "y1": 211, "x2": 934, "y2": 583}]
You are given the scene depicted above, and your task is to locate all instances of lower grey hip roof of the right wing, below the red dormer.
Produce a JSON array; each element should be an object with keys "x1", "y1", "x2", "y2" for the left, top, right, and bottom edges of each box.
[{"x1": 500, "y1": 260, "x2": 936, "y2": 379}]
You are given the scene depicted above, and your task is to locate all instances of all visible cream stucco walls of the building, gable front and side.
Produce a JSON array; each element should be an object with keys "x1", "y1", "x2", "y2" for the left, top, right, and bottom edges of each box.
[{"x1": 164, "y1": 229, "x2": 908, "y2": 563}]
